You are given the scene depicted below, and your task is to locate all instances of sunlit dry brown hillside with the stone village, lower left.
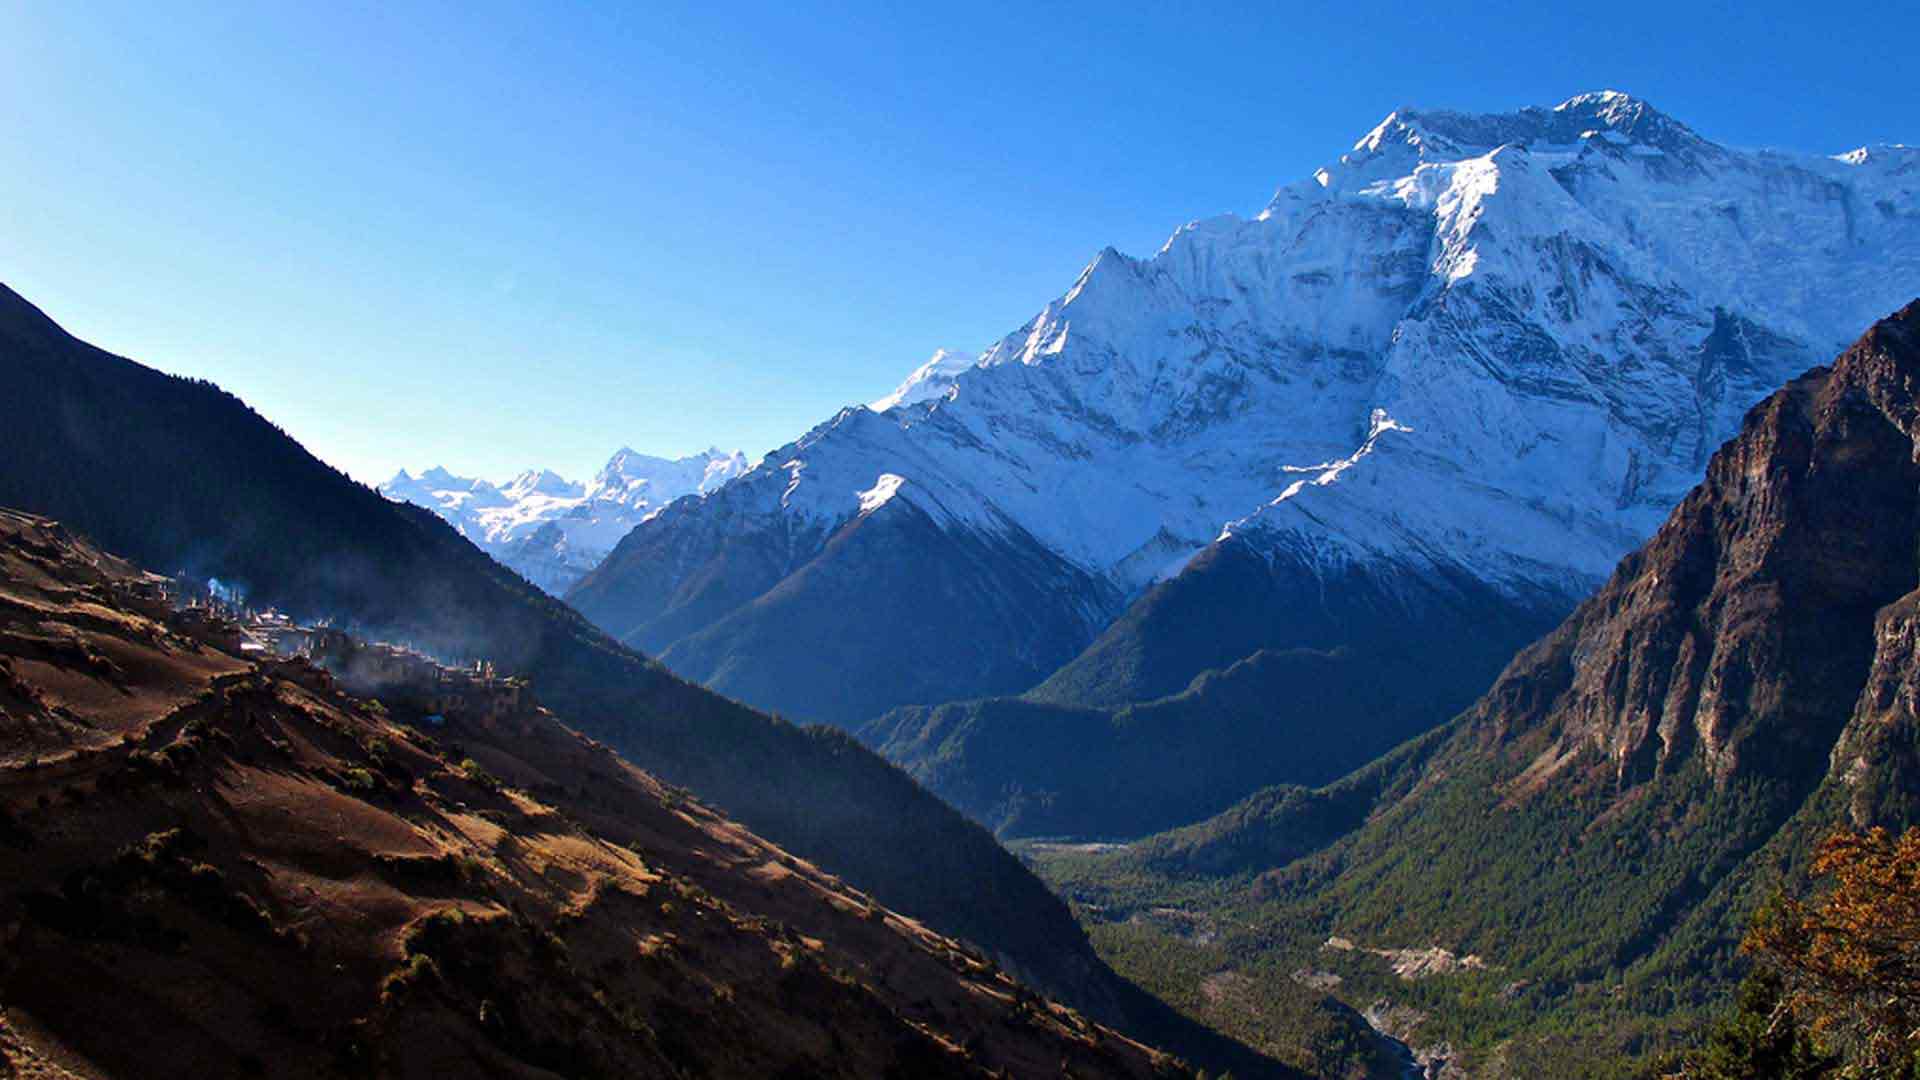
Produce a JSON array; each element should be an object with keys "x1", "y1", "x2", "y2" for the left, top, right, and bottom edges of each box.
[{"x1": 0, "y1": 511, "x2": 1183, "y2": 1078}]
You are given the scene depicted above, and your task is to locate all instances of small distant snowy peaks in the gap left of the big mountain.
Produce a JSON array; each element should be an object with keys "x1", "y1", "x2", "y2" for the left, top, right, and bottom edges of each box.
[{"x1": 380, "y1": 448, "x2": 747, "y2": 594}]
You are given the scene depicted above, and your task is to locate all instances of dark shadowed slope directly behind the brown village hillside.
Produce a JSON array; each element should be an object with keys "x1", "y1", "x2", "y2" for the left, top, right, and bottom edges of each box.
[{"x1": 0, "y1": 278, "x2": 1290, "y2": 1057}]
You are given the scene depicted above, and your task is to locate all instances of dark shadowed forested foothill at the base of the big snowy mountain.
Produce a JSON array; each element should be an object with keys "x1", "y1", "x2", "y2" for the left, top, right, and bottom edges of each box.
[{"x1": 860, "y1": 564, "x2": 1561, "y2": 838}]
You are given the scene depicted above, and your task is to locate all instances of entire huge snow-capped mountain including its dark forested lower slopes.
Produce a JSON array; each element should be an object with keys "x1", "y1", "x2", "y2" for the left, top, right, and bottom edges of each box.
[{"x1": 566, "y1": 90, "x2": 1920, "y2": 838}]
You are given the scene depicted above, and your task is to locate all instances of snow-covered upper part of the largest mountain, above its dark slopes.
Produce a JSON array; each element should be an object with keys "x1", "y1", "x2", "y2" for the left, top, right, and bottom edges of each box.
[{"x1": 764, "y1": 90, "x2": 1920, "y2": 584}]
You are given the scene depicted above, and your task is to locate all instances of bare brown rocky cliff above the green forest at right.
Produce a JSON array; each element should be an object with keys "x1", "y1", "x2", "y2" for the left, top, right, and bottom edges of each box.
[{"x1": 1473, "y1": 304, "x2": 1920, "y2": 796}]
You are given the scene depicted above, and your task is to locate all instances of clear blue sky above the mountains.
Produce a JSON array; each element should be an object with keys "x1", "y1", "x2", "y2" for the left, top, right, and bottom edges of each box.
[{"x1": 0, "y1": 0, "x2": 1920, "y2": 480}]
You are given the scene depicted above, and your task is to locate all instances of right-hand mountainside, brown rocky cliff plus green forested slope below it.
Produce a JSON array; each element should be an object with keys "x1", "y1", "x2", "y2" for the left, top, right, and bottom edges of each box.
[{"x1": 1052, "y1": 302, "x2": 1920, "y2": 1074}]
